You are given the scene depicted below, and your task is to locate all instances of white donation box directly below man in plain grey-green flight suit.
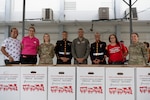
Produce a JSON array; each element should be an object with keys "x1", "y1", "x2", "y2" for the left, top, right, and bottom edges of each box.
[{"x1": 77, "y1": 67, "x2": 105, "y2": 100}]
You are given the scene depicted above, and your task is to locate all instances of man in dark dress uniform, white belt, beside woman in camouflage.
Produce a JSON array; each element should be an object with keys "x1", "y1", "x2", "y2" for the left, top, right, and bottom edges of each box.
[{"x1": 55, "y1": 31, "x2": 72, "y2": 64}]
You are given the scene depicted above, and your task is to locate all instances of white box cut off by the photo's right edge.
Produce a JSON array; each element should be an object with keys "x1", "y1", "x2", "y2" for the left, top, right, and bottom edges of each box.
[{"x1": 136, "y1": 68, "x2": 150, "y2": 100}]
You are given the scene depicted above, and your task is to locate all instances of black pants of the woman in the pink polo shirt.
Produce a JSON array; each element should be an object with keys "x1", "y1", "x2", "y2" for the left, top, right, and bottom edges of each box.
[{"x1": 20, "y1": 55, "x2": 37, "y2": 64}]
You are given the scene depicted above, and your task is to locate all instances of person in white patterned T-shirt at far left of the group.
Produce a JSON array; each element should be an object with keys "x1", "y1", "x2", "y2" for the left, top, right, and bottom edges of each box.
[{"x1": 1, "y1": 28, "x2": 21, "y2": 65}]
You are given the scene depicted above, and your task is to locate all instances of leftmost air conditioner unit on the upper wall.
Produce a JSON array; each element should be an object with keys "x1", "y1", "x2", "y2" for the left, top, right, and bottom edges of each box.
[{"x1": 42, "y1": 8, "x2": 53, "y2": 21}]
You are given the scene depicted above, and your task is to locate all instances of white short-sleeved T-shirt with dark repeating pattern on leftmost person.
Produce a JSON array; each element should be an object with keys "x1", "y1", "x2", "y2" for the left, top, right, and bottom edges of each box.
[{"x1": 2, "y1": 37, "x2": 21, "y2": 61}]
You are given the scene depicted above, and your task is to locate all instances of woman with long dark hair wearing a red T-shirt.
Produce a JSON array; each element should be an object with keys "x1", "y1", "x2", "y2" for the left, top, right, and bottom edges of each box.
[{"x1": 106, "y1": 34, "x2": 127, "y2": 64}]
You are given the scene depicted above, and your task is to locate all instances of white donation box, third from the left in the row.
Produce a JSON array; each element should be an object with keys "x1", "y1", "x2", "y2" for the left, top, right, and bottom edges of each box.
[{"x1": 48, "y1": 66, "x2": 75, "y2": 100}]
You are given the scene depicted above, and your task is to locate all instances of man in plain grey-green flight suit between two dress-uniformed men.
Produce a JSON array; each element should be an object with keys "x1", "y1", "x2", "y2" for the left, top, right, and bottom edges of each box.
[{"x1": 71, "y1": 28, "x2": 90, "y2": 64}]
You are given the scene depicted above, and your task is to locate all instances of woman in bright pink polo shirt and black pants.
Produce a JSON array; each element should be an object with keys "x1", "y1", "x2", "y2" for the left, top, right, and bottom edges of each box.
[{"x1": 21, "y1": 26, "x2": 39, "y2": 64}]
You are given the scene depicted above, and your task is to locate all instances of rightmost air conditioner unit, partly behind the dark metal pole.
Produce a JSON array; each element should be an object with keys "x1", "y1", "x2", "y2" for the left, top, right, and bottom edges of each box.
[{"x1": 125, "y1": 7, "x2": 138, "y2": 20}]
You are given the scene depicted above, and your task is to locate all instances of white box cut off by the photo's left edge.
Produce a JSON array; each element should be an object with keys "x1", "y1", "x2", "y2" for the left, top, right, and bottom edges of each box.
[{"x1": 0, "y1": 67, "x2": 20, "y2": 100}]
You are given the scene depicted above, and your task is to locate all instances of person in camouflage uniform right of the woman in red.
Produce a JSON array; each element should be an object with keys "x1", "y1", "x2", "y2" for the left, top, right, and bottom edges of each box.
[{"x1": 128, "y1": 33, "x2": 148, "y2": 65}]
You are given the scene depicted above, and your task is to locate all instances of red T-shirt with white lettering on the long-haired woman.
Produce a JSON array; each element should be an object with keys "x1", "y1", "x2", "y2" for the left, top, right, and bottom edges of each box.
[{"x1": 107, "y1": 44, "x2": 126, "y2": 63}]
